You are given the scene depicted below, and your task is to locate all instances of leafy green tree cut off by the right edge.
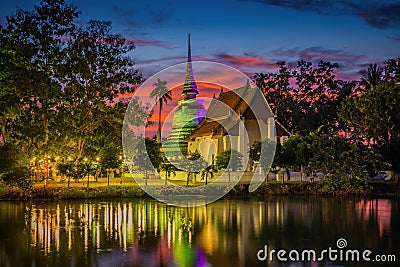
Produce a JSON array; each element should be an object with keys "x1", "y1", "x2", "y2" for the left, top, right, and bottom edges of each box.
[{"x1": 339, "y1": 58, "x2": 400, "y2": 178}]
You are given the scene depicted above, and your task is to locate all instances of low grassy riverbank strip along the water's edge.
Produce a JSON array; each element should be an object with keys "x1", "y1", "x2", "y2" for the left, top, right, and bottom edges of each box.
[{"x1": 0, "y1": 181, "x2": 400, "y2": 200}]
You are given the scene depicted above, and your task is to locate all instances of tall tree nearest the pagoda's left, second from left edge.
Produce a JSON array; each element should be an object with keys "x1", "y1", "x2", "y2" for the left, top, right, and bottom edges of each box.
[{"x1": 61, "y1": 20, "x2": 141, "y2": 158}]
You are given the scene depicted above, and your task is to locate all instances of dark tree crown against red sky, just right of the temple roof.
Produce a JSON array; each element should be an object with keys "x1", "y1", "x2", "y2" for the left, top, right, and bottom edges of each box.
[{"x1": 254, "y1": 60, "x2": 353, "y2": 134}]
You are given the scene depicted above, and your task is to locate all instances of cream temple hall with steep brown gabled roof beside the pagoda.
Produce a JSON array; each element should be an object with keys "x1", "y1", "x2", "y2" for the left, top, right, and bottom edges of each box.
[{"x1": 185, "y1": 82, "x2": 291, "y2": 168}]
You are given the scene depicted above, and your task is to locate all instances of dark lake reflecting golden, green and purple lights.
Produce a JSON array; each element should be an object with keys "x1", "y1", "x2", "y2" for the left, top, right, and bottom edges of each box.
[{"x1": 0, "y1": 197, "x2": 400, "y2": 267}]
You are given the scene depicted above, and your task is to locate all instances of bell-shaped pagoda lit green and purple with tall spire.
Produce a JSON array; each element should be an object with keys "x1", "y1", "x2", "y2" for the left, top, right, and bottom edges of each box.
[{"x1": 163, "y1": 34, "x2": 207, "y2": 156}]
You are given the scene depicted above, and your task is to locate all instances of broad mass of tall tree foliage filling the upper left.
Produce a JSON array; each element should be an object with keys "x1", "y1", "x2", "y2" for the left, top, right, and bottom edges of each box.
[{"x1": 0, "y1": 0, "x2": 141, "y2": 165}]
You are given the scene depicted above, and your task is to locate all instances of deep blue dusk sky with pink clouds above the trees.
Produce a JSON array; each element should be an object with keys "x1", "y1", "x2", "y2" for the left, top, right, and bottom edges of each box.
[{"x1": 0, "y1": 0, "x2": 400, "y2": 79}]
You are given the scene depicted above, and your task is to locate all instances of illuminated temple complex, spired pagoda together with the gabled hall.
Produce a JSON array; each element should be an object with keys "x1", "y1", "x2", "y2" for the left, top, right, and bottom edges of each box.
[{"x1": 163, "y1": 35, "x2": 291, "y2": 169}]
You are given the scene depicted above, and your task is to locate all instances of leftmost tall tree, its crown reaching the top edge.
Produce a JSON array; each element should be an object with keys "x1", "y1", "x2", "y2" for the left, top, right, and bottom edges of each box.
[{"x1": 0, "y1": 0, "x2": 79, "y2": 157}]
